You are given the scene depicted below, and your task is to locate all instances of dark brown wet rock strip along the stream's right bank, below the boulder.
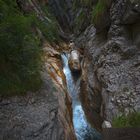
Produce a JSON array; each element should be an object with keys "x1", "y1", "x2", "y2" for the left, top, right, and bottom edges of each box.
[{"x1": 80, "y1": 57, "x2": 103, "y2": 131}]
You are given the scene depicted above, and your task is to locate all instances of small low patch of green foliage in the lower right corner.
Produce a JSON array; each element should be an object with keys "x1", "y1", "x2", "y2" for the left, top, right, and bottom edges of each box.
[{"x1": 112, "y1": 112, "x2": 140, "y2": 127}]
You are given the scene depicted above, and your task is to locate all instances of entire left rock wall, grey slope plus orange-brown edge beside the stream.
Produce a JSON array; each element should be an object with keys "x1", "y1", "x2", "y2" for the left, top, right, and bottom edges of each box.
[{"x1": 0, "y1": 43, "x2": 76, "y2": 140}]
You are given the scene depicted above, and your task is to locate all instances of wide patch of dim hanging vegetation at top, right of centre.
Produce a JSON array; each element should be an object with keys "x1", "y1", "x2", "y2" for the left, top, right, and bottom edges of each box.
[{"x1": 73, "y1": 0, "x2": 112, "y2": 30}]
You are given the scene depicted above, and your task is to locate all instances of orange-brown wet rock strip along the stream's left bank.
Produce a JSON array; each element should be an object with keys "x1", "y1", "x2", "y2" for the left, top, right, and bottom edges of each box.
[{"x1": 44, "y1": 42, "x2": 76, "y2": 140}]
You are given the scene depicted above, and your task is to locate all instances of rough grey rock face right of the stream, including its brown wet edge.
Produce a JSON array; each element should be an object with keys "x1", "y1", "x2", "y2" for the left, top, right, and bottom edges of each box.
[{"x1": 76, "y1": 0, "x2": 140, "y2": 129}]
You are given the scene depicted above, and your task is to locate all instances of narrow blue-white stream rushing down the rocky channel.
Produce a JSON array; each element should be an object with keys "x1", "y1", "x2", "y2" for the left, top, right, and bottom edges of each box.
[{"x1": 61, "y1": 53, "x2": 101, "y2": 140}]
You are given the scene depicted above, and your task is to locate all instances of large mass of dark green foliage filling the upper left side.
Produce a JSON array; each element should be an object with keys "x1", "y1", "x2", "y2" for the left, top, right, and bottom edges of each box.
[{"x1": 0, "y1": 0, "x2": 42, "y2": 95}]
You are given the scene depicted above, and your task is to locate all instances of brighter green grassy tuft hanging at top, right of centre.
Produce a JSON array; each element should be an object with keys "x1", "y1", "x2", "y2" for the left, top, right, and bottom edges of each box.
[{"x1": 92, "y1": 0, "x2": 111, "y2": 24}]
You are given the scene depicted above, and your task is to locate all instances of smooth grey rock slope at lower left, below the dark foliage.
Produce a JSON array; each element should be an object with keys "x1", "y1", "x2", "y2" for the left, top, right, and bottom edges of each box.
[{"x1": 0, "y1": 74, "x2": 65, "y2": 140}]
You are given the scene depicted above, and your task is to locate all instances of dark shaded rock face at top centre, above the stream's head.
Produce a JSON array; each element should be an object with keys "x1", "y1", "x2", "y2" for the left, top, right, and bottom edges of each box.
[{"x1": 48, "y1": 0, "x2": 94, "y2": 35}]
